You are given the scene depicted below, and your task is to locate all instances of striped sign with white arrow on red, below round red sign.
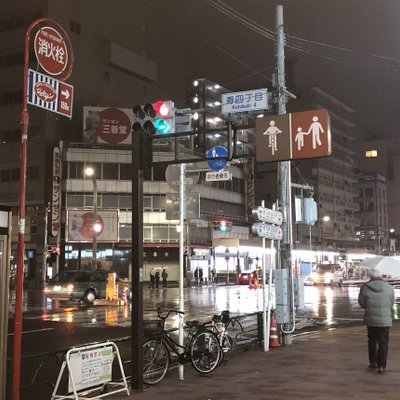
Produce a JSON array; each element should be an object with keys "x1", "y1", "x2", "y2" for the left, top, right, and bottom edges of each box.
[{"x1": 28, "y1": 69, "x2": 74, "y2": 118}]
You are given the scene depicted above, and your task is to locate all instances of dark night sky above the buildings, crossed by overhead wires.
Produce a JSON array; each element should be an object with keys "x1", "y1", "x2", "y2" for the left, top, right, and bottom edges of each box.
[{"x1": 176, "y1": 0, "x2": 400, "y2": 137}]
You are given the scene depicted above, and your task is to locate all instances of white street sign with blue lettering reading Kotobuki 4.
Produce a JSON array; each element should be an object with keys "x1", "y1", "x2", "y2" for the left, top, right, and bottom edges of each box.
[{"x1": 221, "y1": 89, "x2": 268, "y2": 114}]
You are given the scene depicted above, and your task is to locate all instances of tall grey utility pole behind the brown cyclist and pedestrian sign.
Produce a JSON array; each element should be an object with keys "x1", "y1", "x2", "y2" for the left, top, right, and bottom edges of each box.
[{"x1": 276, "y1": 5, "x2": 294, "y2": 345}]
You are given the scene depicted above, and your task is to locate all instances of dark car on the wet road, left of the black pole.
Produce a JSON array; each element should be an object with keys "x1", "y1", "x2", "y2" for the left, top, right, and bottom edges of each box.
[{"x1": 43, "y1": 270, "x2": 132, "y2": 304}]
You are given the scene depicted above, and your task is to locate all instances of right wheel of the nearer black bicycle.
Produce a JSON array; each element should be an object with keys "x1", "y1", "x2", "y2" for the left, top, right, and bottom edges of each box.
[{"x1": 190, "y1": 331, "x2": 222, "y2": 374}]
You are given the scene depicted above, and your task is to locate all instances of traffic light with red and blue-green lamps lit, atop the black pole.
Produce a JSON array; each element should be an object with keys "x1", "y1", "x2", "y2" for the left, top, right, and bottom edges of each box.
[{"x1": 132, "y1": 100, "x2": 175, "y2": 135}]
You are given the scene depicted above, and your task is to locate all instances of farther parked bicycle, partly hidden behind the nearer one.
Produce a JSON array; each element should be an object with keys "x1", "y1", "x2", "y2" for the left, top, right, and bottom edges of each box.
[{"x1": 212, "y1": 310, "x2": 243, "y2": 365}]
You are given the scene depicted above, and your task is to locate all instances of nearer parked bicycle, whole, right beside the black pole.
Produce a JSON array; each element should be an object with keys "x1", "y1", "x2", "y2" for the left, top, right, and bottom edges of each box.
[{"x1": 143, "y1": 309, "x2": 223, "y2": 385}]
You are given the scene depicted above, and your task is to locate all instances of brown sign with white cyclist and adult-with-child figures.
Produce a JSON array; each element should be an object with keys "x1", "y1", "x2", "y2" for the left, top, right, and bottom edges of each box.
[{"x1": 256, "y1": 109, "x2": 332, "y2": 162}]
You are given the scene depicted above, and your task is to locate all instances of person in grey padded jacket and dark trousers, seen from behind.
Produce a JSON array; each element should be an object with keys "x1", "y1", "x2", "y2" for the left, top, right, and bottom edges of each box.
[{"x1": 358, "y1": 269, "x2": 394, "y2": 374}]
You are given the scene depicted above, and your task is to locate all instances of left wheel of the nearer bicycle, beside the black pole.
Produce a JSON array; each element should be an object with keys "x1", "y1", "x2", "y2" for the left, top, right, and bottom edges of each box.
[{"x1": 143, "y1": 339, "x2": 169, "y2": 385}]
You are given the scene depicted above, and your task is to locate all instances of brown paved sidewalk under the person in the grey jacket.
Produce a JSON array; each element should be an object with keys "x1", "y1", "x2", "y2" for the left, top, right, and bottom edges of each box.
[{"x1": 108, "y1": 321, "x2": 400, "y2": 400}]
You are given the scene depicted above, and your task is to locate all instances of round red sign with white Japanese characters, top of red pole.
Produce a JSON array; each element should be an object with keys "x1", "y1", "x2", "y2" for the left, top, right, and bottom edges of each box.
[{"x1": 34, "y1": 26, "x2": 68, "y2": 75}]
